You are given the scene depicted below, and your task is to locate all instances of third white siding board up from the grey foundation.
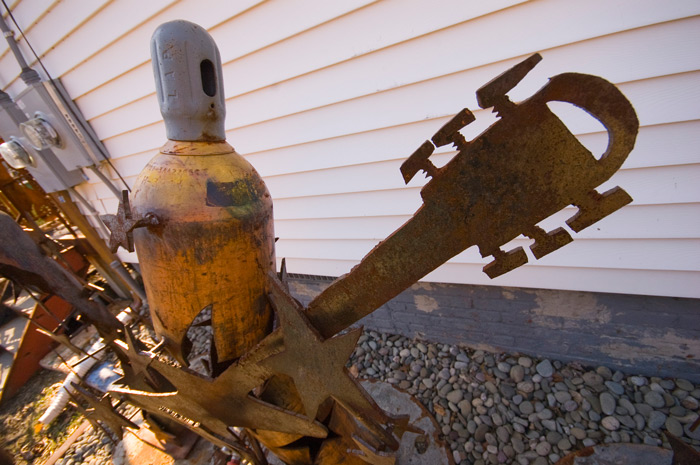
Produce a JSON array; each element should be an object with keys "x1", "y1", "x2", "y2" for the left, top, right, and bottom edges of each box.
[{"x1": 275, "y1": 203, "x2": 700, "y2": 240}]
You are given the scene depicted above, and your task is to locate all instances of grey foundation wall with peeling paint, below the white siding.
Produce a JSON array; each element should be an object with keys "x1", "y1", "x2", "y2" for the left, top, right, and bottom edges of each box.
[{"x1": 290, "y1": 275, "x2": 700, "y2": 382}]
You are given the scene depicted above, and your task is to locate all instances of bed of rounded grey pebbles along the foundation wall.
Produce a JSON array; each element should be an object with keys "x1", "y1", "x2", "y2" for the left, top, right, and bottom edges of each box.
[{"x1": 53, "y1": 331, "x2": 700, "y2": 465}]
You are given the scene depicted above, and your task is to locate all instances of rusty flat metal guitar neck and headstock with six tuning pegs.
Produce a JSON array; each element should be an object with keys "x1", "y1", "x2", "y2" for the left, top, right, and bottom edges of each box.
[{"x1": 308, "y1": 55, "x2": 639, "y2": 337}]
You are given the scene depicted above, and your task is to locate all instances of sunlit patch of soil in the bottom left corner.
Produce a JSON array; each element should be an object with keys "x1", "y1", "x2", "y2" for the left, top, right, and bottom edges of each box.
[{"x1": 0, "y1": 370, "x2": 82, "y2": 465}]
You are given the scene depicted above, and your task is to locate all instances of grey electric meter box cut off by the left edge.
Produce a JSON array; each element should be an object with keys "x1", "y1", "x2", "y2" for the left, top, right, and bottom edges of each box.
[{"x1": 0, "y1": 93, "x2": 85, "y2": 192}]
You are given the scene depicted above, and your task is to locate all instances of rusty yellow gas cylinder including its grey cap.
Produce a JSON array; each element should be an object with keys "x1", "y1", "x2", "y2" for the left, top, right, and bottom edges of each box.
[{"x1": 132, "y1": 21, "x2": 276, "y2": 362}]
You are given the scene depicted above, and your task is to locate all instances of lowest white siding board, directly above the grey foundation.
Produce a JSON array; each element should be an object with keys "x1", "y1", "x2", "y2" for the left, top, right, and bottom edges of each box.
[{"x1": 277, "y1": 254, "x2": 700, "y2": 298}]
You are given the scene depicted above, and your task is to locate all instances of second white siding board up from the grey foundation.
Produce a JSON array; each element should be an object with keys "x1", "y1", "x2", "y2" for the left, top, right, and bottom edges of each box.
[{"x1": 276, "y1": 238, "x2": 700, "y2": 271}]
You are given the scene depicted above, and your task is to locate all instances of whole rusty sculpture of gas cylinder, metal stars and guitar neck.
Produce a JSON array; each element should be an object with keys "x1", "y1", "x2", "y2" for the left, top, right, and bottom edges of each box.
[{"x1": 100, "y1": 21, "x2": 638, "y2": 464}]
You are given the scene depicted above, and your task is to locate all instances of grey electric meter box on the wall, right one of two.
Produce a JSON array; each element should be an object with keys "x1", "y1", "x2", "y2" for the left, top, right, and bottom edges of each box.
[{"x1": 15, "y1": 79, "x2": 107, "y2": 170}]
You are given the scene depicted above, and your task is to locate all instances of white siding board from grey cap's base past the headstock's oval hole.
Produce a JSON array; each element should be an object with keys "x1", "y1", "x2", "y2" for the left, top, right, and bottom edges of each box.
[{"x1": 233, "y1": 72, "x2": 700, "y2": 153}]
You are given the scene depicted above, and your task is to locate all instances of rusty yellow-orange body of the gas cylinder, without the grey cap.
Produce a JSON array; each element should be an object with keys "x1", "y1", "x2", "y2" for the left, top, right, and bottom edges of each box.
[{"x1": 132, "y1": 141, "x2": 275, "y2": 362}]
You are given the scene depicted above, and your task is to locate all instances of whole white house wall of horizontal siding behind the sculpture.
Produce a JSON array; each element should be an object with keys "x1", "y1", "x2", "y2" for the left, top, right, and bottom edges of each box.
[{"x1": 0, "y1": 0, "x2": 700, "y2": 298}]
